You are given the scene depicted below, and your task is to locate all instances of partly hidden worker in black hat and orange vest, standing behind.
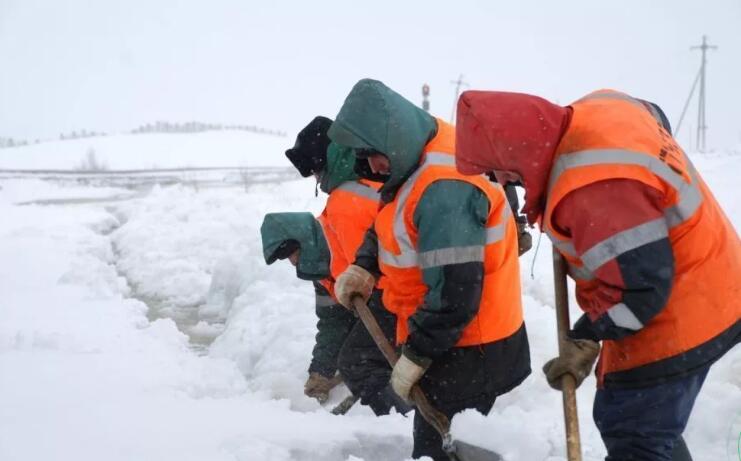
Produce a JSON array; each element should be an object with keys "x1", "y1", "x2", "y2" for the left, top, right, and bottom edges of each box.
[{"x1": 286, "y1": 116, "x2": 409, "y2": 415}]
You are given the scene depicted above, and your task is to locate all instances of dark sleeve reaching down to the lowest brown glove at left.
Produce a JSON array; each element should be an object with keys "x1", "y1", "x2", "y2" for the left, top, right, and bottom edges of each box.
[{"x1": 309, "y1": 282, "x2": 356, "y2": 377}]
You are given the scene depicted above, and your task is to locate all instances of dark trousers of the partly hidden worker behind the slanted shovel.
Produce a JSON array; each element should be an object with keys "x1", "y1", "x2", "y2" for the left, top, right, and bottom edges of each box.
[{"x1": 337, "y1": 291, "x2": 406, "y2": 415}]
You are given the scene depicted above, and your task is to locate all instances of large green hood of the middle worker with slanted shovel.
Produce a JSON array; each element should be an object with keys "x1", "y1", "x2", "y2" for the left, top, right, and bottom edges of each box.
[{"x1": 327, "y1": 79, "x2": 437, "y2": 196}]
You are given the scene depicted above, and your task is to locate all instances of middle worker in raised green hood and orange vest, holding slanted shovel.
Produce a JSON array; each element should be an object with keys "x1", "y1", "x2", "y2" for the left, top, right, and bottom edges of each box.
[{"x1": 329, "y1": 79, "x2": 530, "y2": 460}]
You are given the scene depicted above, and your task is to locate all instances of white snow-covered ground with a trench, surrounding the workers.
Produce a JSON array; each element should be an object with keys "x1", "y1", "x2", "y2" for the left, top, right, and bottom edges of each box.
[{"x1": 0, "y1": 145, "x2": 741, "y2": 461}]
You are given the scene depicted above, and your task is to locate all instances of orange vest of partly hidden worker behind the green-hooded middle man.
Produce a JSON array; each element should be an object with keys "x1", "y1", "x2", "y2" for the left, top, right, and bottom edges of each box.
[{"x1": 317, "y1": 179, "x2": 382, "y2": 297}]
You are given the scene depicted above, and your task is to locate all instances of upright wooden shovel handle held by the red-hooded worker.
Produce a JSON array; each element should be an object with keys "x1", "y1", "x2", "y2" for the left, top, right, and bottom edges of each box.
[{"x1": 553, "y1": 247, "x2": 581, "y2": 461}]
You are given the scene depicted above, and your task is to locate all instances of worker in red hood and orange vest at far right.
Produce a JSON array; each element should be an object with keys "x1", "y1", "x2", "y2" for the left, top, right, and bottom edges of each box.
[{"x1": 456, "y1": 90, "x2": 741, "y2": 461}]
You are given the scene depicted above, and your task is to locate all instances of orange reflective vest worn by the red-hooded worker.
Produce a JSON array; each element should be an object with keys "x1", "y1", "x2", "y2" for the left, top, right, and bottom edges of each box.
[{"x1": 543, "y1": 90, "x2": 741, "y2": 383}]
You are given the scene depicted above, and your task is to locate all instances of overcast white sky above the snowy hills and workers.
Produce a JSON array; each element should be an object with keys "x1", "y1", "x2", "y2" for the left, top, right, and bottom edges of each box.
[{"x1": 0, "y1": 0, "x2": 741, "y2": 148}]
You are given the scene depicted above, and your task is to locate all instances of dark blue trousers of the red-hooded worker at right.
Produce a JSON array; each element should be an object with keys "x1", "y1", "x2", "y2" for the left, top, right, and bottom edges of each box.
[{"x1": 593, "y1": 368, "x2": 709, "y2": 461}]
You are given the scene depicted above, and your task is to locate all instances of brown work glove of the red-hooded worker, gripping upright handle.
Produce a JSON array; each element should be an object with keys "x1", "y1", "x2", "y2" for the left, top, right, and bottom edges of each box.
[{"x1": 543, "y1": 338, "x2": 599, "y2": 391}]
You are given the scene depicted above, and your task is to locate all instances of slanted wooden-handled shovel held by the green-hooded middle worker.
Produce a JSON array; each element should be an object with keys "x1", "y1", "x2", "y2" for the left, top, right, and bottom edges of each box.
[{"x1": 352, "y1": 296, "x2": 502, "y2": 461}]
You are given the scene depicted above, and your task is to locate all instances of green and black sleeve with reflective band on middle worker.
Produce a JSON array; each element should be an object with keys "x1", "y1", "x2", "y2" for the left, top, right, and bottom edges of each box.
[{"x1": 404, "y1": 180, "x2": 489, "y2": 361}]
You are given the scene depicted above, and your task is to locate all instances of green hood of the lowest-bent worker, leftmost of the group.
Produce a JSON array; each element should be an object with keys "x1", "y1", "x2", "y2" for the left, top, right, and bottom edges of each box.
[{"x1": 260, "y1": 212, "x2": 330, "y2": 280}]
